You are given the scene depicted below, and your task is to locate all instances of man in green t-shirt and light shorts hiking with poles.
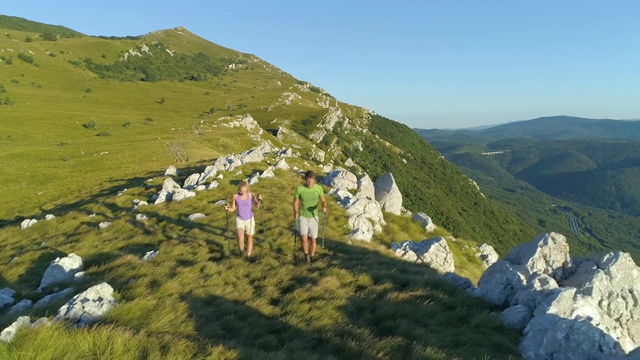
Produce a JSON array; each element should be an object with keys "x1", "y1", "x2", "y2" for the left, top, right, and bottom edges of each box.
[{"x1": 293, "y1": 170, "x2": 327, "y2": 263}]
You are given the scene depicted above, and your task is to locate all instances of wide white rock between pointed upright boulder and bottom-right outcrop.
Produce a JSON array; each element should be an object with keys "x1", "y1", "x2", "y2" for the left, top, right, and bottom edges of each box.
[{"x1": 391, "y1": 236, "x2": 455, "y2": 274}]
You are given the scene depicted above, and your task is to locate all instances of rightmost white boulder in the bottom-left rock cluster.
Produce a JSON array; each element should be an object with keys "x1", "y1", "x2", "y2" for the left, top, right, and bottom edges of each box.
[{"x1": 53, "y1": 282, "x2": 116, "y2": 327}]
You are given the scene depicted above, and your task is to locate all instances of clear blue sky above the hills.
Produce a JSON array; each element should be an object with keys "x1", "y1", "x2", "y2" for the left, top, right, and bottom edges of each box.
[{"x1": 0, "y1": 0, "x2": 640, "y2": 129}]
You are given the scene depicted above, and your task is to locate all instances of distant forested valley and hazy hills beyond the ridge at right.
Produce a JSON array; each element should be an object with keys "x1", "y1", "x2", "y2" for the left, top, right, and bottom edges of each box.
[{"x1": 415, "y1": 116, "x2": 640, "y2": 260}]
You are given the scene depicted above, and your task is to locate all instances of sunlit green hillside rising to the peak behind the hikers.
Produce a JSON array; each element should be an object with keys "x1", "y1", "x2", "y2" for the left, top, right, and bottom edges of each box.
[{"x1": 0, "y1": 19, "x2": 534, "y2": 253}]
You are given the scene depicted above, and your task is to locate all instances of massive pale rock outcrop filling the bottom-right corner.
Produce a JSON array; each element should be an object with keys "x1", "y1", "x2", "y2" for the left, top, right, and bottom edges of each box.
[{"x1": 476, "y1": 233, "x2": 640, "y2": 359}]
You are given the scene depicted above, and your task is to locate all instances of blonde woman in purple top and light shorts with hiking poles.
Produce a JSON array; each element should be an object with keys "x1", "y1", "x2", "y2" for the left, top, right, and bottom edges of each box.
[{"x1": 224, "y1": 180, "x2": 262, "y2": 261}]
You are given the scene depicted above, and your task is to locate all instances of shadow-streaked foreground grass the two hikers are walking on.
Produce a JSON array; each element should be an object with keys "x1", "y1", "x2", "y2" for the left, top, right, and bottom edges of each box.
[{"x1": 0, "y1": 167, "x2": 519, "y2": 359}]
